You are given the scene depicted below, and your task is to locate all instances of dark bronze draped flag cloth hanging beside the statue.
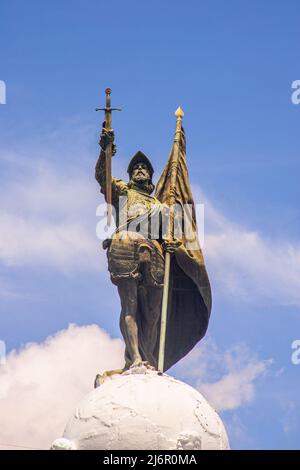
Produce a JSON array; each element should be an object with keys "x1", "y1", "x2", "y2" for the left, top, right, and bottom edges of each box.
[{"x1": 155, "y1": 123, "x2": 211, "y2": 370}]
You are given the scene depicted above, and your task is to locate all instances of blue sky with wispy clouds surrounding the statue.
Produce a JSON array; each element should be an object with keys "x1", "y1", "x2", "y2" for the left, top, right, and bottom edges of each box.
[{"x1": 0, "y1": 0, "x2": 300, "y2": 449}]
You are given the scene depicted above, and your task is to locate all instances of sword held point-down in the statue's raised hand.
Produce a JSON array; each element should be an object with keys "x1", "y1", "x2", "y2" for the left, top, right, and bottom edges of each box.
[{"x1": 96, "y1": 88, "x2": 122, "y2": 226}]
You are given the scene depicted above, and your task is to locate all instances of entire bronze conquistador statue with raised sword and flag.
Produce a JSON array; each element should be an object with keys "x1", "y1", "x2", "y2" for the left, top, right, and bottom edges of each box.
[{"x1": 95, "y1": 89, "x2": 211, "y2": 372}]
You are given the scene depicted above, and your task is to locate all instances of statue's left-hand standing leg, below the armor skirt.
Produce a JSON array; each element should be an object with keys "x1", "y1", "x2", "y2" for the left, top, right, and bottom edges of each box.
[{"x1": 118, "y1": 279, "x2": 142, "y2": 365}]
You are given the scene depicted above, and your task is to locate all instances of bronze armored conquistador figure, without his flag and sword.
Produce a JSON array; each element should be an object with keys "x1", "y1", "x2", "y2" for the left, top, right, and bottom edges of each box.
[{"x1": 96, "y1": 129, "x2": 168, "y2": 368}]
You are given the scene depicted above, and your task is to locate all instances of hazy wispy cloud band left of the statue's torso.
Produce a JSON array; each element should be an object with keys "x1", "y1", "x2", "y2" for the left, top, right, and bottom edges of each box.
[{"x1": 0, "y1": 164, "x2": 104, "y2": 271}]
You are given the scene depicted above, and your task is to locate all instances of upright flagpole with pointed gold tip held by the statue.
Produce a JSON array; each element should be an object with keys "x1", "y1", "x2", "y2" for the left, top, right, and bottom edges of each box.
[{"x1": 158, "y1": 107, "x2": 184, "y2": 374}]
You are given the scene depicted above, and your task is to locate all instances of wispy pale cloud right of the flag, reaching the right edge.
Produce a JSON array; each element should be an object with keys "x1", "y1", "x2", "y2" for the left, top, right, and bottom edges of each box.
[{"x1": 194, "y1": 187, "x2": 300, "y2": 305}]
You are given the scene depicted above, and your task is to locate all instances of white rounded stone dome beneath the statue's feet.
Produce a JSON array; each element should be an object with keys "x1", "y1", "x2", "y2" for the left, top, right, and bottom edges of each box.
[{"x1": 55, "y1": 367, "x2": 229, "y2": 450}]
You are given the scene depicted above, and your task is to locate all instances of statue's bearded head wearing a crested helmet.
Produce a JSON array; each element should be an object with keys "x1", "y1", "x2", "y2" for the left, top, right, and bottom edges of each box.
[{"x1": 127, "y1": 151, "x2": 154, "y2": 194}]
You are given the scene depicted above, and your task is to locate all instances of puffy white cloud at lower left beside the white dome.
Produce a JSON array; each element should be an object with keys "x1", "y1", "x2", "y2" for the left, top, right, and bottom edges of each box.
[{"x1": 0, "y1": 325, "x2": 123, "y2": 449}]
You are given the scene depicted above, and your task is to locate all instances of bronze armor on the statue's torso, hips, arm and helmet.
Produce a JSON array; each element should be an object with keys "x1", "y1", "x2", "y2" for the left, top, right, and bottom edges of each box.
[{"x1": 96, "y1": 148, "x2": 164, "y2": 287}]
